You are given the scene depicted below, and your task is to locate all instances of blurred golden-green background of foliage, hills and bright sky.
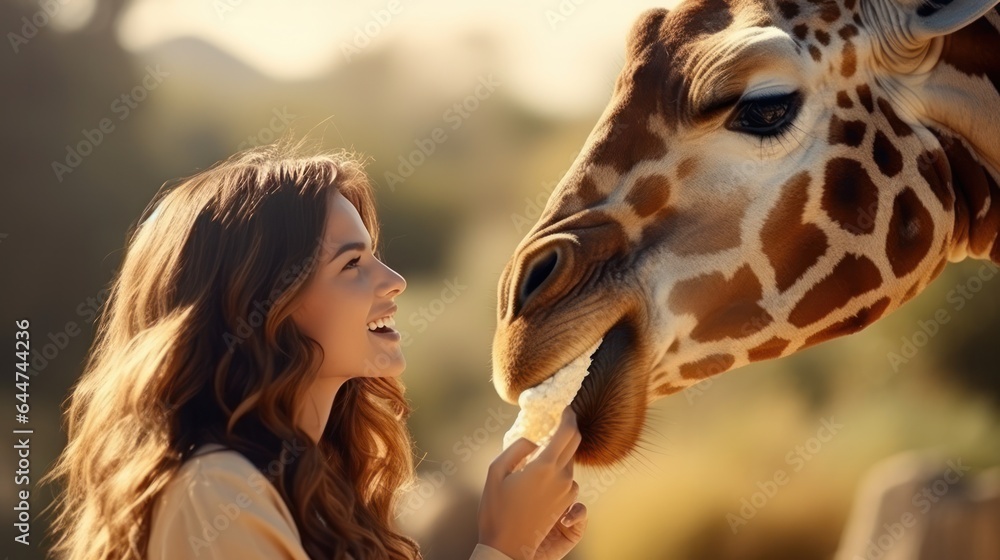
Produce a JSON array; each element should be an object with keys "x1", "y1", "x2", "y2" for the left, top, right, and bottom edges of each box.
[{"x1": 0, "y1": 0, "x2": 1000, "y2": 560}]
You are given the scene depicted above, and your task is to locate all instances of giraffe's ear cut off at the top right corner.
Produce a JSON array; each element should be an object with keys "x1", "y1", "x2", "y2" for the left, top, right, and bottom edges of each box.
[{"x1": 895, "y1": 0, "x2": 1000, "y2": 41}]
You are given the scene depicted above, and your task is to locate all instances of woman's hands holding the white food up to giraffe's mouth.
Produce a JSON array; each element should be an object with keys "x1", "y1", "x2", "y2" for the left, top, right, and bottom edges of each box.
[{"x1": 479, "y1": 407, "x2": 586, "y2": 560}]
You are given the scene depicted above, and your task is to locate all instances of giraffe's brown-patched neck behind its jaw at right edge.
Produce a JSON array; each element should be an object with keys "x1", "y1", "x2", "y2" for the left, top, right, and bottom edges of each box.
[{"x1": 920, "y1": 8, "x2": 1000, "y2": 263}]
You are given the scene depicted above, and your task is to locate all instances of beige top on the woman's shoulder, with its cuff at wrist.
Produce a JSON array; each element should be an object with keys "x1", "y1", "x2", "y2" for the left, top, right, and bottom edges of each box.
[{"x1": 148, "y1": 444, "x2": 511, "y2": 560}]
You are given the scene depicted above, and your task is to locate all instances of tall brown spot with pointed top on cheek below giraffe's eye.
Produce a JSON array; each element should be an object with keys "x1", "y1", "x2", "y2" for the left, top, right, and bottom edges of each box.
[{"x1": 760, "y1": 171, "x2": 828, "y2": 292}]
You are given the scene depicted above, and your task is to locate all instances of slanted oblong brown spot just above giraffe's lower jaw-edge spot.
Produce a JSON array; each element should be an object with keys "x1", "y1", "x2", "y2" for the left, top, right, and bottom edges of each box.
[{"x1": 788, "y1": 253, "x2": 882, "y2": 327}]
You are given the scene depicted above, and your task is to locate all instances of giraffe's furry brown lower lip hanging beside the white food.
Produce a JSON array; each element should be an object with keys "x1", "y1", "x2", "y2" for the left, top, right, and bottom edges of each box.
[{"x1": 570, "y1": 319, "x2": 648, "y2": 465}]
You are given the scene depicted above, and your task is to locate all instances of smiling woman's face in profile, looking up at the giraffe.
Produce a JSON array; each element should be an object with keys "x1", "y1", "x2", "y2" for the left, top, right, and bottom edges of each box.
[{"x1": 292, "y1": 191, "x2": 406, "y2": 378}]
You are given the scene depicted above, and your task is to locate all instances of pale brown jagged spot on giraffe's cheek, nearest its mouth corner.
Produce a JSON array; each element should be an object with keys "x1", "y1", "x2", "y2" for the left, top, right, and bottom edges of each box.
[{"x1": 668, "y1": 264, "x2": 774, "y2": 342}]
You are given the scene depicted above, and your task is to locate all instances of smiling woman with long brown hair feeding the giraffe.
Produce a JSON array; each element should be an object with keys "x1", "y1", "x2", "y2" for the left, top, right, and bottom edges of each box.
[{"x1": 46, "y1": 137, "x2": 586, "y2": 560}]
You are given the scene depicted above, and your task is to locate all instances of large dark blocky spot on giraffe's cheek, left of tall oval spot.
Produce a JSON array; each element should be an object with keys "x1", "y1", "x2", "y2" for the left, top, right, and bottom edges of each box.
[{"x1": 822, "y1": 158, "x2": 878, "y2": 235}]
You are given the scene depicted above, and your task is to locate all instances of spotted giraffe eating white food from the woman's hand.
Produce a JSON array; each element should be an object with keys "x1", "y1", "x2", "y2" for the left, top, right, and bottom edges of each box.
[{"x1": 493, "y1": 0, "x2": 1000, "y2": 465}]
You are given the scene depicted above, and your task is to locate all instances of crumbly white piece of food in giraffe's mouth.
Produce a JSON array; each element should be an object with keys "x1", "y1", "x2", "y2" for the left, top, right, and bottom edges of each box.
[{"x1": 503, "y1": 338, "x2": 604, "y2": 461}]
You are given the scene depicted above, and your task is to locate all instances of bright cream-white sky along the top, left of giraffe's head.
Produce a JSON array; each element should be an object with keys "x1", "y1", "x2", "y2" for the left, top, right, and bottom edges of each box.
[{"x1": 118, "y1": 0, "x2": 676, "y2": 116}]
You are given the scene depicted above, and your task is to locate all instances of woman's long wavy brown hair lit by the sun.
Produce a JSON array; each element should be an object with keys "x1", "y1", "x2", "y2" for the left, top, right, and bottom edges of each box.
[{"x1": 45, "y1": 138, "x2": 421, "y2": 560}]
